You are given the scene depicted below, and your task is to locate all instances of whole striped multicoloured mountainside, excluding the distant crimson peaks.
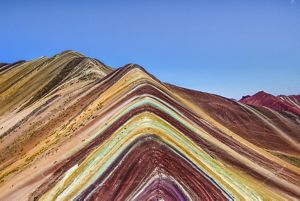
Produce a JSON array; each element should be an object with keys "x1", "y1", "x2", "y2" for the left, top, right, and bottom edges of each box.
[{"x1": 0, "y1": 51, "x2": 300, "y2": 200}]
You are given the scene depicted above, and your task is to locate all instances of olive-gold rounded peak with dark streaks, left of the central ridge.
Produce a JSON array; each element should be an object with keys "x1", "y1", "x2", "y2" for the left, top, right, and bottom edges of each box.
[{"x1": 0, "y1": 50, "x2": 113, "y2": 113}]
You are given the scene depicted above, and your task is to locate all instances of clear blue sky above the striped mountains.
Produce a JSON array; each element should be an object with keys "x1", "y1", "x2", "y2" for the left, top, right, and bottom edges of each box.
[{"x1": 0, "y1": 0, "x2": 300, "y2": 99}]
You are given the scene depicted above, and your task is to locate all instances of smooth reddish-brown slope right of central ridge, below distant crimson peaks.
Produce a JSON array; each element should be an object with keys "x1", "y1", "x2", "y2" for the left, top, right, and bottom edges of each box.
[{"x1": 169, "y1": 85, "x2": 300, "y2": 156}]
